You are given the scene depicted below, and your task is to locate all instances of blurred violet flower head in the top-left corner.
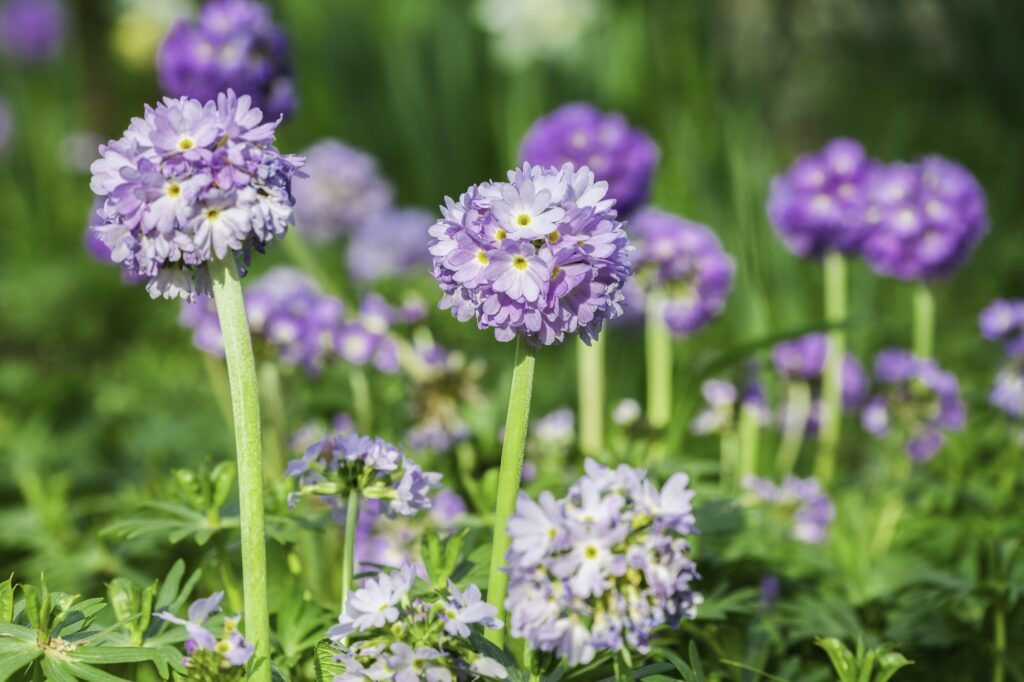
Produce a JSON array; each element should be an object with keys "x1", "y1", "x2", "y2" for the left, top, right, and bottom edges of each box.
[{"x1": 0, "y1": 0, "x2": 68, "y2": 63}]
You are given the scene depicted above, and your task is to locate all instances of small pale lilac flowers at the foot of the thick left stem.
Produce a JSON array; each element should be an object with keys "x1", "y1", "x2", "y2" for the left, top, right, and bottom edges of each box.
[{"x1": 154, "y1": 592, "x2": 253, "y2": 667}]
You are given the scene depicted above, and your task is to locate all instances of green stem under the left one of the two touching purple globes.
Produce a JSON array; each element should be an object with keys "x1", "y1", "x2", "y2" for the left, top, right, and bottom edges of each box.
[{"x1": 815, "y1": 251, "x2": 847, "y2": 485}]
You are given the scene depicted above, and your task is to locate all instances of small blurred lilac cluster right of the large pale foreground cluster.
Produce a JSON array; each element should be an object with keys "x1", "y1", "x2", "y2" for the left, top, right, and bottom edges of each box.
[{"x1": 743, "y1": 476, "x2": 836, "y2": 545}]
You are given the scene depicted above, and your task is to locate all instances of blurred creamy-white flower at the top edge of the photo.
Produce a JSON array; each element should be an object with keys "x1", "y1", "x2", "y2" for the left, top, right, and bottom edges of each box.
[{"x1": 475, "y1": 0, "x2": 603, "y2": 70}]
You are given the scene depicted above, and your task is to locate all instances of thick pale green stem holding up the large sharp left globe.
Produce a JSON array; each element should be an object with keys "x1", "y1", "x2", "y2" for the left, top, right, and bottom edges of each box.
[{"x1": 210, "y1": 258, "x2": 270, "y2": 682}]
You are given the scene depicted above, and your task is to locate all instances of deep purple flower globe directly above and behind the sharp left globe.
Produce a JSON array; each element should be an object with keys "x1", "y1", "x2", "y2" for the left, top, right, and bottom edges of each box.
[{"x1": 157, "y1": 0, "x2": 295, "y2": 118}]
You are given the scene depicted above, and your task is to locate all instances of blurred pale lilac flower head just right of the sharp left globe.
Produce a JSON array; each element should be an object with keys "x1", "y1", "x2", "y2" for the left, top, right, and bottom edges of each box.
[{"x1": 294, "y1": 139, "x2": 395, "y2": 243}]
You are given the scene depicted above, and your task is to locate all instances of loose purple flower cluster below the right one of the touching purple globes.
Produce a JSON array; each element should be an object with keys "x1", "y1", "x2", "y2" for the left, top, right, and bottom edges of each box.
[{"x1": 860, "y1": 348, "x2": 967, "y2": 461}]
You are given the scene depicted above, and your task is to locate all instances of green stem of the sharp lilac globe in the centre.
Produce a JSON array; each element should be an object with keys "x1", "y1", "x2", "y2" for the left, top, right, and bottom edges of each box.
[{"x1": 487, "y1": 338, "x2": 537, "y2": 647}]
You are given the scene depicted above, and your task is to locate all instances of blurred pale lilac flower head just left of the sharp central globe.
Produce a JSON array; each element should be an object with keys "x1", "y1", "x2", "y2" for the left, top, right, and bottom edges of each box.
[{"x1": 344, "y1": 208, "x2": 433, "y2": 283}]
